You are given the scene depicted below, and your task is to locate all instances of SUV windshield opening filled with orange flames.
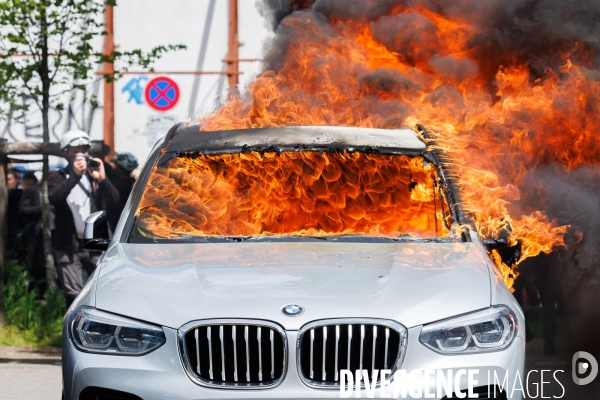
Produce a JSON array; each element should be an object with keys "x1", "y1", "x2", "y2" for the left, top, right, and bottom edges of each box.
[{"x1": 132, "y1": 151, "x2": 452, "y2": 241}]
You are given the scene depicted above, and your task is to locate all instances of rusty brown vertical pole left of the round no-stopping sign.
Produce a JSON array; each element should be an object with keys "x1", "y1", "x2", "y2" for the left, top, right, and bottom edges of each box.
[{"x1": 103, "y1": 4, "x2": 115, "y2": 156}]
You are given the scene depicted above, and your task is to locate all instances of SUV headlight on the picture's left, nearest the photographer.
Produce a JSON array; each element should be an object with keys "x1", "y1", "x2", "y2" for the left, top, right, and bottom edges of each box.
[{"x1": 69, "y1": 307, "x2": 166, "y2": 356}]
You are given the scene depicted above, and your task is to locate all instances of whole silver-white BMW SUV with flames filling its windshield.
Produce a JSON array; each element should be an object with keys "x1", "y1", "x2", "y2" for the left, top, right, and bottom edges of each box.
[{"x1": 63, "y1": 125, "x2": 525, "y2": 400}]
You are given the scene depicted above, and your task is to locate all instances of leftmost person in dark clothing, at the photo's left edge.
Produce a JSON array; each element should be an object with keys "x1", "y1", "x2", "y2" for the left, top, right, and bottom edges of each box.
[{"x1": 6, "y1": 169, "x2": 24, "y2": 259}]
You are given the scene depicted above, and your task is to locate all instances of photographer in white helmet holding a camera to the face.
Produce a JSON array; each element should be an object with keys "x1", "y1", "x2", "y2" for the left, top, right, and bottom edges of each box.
[{"x1": 48, "y1": 130, "x2": 119, "y2": 307}]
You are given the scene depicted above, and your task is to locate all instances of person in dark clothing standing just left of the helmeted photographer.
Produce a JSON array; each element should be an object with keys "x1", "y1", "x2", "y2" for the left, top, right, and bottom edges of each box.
[{"x1": 19, "y1": 180, "x2": 46, "y2": 293}]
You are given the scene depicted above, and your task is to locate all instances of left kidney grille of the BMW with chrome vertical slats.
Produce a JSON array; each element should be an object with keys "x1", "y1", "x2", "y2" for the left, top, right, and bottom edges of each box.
[{"x1": 179, "y1": 319, "x2": 287, "y2": 388}]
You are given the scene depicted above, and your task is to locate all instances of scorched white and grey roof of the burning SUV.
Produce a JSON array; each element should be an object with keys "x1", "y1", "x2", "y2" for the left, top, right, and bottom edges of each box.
[{"x1": 165, "y1": 125, "x2": 427, "y2": 154}]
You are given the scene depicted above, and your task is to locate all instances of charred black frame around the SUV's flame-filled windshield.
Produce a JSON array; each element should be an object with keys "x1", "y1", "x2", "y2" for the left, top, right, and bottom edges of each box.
[{"x1": 120, "y1": 125, "x2": 471, "y2": 243}]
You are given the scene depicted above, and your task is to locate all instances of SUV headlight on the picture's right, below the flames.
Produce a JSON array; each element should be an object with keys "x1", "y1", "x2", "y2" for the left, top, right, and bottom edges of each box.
[{"x1": 419, "y1": 306, "x2": 518, "y2": 354}]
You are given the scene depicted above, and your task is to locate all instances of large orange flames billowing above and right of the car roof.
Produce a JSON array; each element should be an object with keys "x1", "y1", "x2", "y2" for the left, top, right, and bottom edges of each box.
[{"x1": 190, "y1": 1, "x2": 600, "y2": 286}]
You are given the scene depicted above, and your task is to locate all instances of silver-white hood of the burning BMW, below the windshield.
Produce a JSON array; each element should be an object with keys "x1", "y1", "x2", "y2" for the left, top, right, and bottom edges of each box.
[{"x1": 94, "y1": 242, "x2": 491, "y2": 330}]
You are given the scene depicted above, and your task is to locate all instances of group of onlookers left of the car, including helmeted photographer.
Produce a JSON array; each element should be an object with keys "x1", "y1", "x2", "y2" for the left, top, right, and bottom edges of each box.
[{"x1": 6, "y1": 130, "x2": 138, "y2": 307}]
